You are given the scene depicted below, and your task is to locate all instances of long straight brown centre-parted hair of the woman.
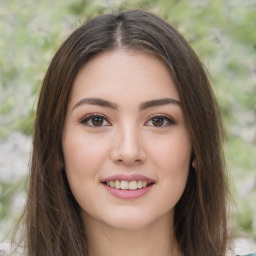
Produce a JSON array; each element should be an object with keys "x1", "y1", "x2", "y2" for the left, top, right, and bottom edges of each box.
[{"x1": 14, "y1": 10, "x2": 227, "y2": 256}]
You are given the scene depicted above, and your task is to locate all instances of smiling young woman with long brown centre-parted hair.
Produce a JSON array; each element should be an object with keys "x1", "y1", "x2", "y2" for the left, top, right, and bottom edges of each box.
[{"x1": 11, "y1": 11, "x2": 254, "y2": 256}]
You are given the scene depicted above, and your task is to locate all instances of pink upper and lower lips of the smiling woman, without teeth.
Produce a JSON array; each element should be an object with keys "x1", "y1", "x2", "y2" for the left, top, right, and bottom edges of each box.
[{"x1": 101, "y1": 174, "x2": 155, "y2": 199}]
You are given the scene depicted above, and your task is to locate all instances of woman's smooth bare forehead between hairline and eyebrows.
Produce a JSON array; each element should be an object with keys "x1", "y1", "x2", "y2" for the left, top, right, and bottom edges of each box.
[{"x1": 70, "y1": 50, "x2": 179, "y2": 106}]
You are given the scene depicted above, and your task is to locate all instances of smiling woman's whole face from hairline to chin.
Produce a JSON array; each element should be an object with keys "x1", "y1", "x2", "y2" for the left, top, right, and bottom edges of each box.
[{"x1": 62, "y1": 50, "x2": 191, "y2": 229}]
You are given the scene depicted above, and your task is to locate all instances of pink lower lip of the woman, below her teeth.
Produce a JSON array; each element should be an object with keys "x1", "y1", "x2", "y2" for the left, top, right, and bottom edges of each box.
[{"x1": 102, "y1": 183, "x2": 154, "y2": 199}]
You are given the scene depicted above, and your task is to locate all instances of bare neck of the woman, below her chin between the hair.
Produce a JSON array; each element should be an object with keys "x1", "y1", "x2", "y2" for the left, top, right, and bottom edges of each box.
[{"x1": 83, "y1": 213, "x2": 182, "y2": 256}]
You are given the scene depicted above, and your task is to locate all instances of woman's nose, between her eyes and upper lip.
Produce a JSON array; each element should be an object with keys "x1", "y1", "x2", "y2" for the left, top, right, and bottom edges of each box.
[{"x1": 111, "y1": 125, "x2": 146, "y2": 166}]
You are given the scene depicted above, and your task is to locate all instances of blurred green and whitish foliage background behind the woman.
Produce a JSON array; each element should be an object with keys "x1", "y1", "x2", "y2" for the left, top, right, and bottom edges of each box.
[{"x1": 0, "y1": 0, "x2": 256, "y2": 246}]
